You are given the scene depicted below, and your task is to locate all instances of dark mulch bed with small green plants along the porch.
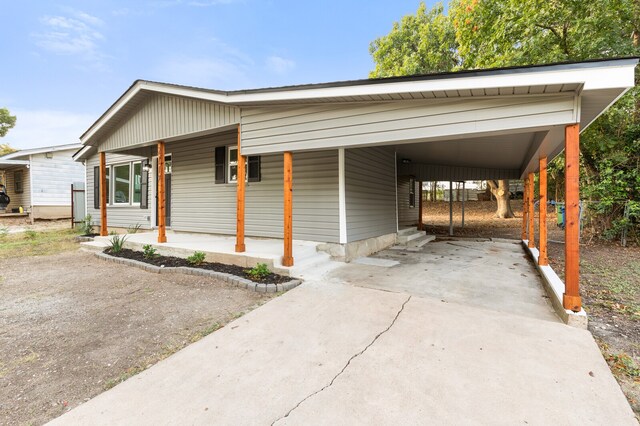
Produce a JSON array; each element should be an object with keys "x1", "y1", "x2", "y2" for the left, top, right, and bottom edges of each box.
[{"x1": 104, "y1": 249, "x2": 291, "y2": 284}]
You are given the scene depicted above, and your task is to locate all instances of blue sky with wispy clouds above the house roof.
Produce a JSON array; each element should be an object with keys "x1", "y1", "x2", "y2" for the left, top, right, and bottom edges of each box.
[{"x1": 0, "y1": 0, "x2": 433, "y2": 149}]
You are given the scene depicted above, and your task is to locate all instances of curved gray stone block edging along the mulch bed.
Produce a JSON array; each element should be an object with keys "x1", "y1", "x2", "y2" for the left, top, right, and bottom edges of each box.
[{"x1": 95, "y1": 252, "x2": 302, "y2": 293}]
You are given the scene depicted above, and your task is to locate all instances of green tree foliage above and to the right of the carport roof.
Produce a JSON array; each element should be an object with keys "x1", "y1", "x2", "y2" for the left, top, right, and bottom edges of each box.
[{"x1": 369, "y1": 0, "x2": 640, "y2": 242}]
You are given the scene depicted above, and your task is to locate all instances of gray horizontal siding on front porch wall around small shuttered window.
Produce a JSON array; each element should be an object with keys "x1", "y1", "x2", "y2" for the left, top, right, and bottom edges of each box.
[{"x1": 167, "y1": 132, "x2": 339, "y2": 242}]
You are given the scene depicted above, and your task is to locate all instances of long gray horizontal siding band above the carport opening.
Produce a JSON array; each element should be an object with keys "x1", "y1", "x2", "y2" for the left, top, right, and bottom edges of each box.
[{"x1": 242, "y1": 95, "x2": 575, "y2": 154}]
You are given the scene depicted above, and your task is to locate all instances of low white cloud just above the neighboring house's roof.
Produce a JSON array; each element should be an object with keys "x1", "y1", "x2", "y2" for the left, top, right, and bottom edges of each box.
[{"x1": 0, "y1": 109, "x2": 98, "y2": 149}]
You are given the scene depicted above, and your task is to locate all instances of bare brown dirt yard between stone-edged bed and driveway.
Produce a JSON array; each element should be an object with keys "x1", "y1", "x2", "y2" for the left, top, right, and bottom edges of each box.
[{"x1": 0, "y1": 250, "x2": 269, "y2": 425}]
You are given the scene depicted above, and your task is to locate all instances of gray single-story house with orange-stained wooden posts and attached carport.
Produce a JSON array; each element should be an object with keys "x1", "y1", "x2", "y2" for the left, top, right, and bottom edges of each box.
[{"x1": 75, "y1": 58, "x2": 638, "y2": 309}]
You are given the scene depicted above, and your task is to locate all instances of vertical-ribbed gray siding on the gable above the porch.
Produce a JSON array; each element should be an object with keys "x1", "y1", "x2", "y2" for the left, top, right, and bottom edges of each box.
[{"x1": 99, "y1": 95, "x2": 240, "y2": 151}]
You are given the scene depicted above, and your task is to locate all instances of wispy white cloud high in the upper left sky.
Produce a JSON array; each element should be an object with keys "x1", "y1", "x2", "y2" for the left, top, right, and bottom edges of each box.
[{"x1": 33, "y1": 9, "x2": 105, "y2": 65}]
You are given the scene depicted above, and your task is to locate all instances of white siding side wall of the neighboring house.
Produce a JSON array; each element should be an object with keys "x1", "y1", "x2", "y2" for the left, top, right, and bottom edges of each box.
[{"x1": 30, "y1": 150, "x2": 84, "y2": 206}]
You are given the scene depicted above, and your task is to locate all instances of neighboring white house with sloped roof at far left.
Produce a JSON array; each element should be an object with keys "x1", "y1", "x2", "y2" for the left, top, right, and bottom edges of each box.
[{"x1": 0, "y1": 144, "x2": 85, "y2": 219}]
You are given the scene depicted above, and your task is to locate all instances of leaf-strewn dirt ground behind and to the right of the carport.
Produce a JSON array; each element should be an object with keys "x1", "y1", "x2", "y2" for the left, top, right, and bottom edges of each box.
[{"x1": 423, "y1": 200, "x2": 640, "y2": 418}]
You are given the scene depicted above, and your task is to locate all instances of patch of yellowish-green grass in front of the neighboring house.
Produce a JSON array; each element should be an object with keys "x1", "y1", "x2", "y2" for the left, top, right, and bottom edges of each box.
[{"x1": 0, "y1": 229, "x2": 78, "y2": 259}]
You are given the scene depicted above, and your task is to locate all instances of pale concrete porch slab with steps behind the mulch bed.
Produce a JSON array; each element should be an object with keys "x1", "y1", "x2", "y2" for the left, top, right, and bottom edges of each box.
[{"x1": 82, "y1": 231, "x2": 340, "y2": 278}]
